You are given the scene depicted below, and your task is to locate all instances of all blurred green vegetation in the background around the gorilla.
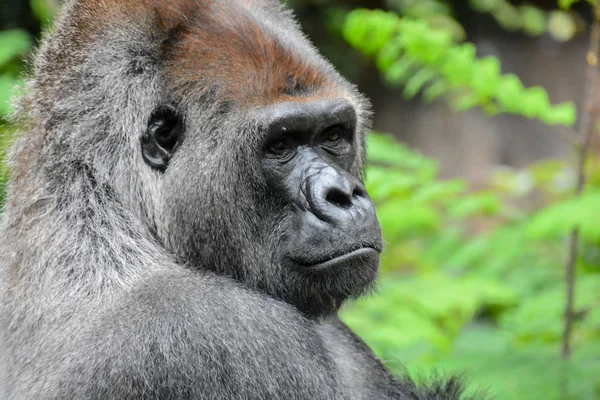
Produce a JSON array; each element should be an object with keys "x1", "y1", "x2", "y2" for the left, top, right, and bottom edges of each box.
[{"x1": 0, "y1": 0, "x2": 600, "y2": 400}]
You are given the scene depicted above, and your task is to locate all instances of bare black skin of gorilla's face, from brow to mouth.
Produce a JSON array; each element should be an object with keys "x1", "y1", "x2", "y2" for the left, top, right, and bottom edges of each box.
[{"x1": 261, "y1": 100, "x2": 381, "y2": 274}]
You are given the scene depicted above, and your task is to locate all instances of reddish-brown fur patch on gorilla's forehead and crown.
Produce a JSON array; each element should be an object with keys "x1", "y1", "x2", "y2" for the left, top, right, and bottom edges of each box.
[{"x1": 163, "y1": 1, "x2": 343, "y2": 106}]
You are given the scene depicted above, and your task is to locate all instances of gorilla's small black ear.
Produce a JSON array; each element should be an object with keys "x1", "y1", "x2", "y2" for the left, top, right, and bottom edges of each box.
[{"x1": 140, "y1": 105, "x2": 185, "y2": 171}]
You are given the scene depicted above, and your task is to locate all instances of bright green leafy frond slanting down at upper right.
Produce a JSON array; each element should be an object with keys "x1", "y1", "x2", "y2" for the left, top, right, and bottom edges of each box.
[{"x1": 344, "y1": 10, "x2": 576, "y2": 125}]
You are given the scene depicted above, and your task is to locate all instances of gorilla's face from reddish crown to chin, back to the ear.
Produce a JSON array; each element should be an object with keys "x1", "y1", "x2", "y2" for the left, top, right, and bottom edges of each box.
[{"x1": 140, "y1": 1, "x2": 382, "y2": 315}]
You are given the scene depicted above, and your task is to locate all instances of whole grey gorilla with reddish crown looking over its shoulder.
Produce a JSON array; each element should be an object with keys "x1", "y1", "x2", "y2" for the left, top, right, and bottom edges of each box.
[{"x1": 0, "y1": 0, "x2": 482, "y2": 400}]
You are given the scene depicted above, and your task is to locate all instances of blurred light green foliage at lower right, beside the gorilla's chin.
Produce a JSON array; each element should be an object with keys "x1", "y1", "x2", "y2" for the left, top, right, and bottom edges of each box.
[{"x1": 344, "y1": 134, "x2": 600, "y2": 400}]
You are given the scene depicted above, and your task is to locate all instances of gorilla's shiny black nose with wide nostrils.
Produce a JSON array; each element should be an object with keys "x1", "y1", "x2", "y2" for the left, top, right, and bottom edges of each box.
[{"x1": 306, "y1": 166, "x2": 374, "y2": 226}]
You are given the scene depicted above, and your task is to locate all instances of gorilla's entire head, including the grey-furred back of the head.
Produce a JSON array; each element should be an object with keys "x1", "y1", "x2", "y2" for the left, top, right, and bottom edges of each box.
[{"x1": 24, "y1": 0, "x2": 382, "y2": 315}]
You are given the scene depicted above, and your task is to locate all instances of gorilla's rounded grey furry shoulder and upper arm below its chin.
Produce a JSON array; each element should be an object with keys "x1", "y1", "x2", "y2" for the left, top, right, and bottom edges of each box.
[{"x1": 35, "y1": 269, "x2": 351, "y2": 400}]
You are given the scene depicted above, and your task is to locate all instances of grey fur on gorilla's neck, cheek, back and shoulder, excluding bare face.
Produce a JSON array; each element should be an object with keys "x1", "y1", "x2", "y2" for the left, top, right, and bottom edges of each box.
[{"x1": 0, "y1": 0, "x2": 486, "y2": 400}]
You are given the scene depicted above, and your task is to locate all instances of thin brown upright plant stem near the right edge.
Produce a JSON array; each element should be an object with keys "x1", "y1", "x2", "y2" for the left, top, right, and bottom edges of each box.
[{"x1": 561, "y1": 5, "x2": 600, "y2": 360}]
